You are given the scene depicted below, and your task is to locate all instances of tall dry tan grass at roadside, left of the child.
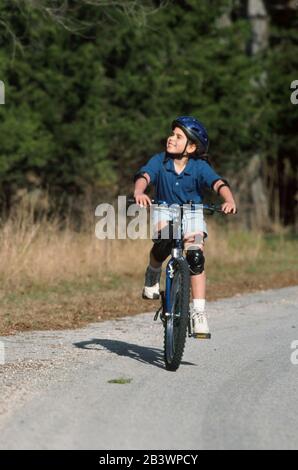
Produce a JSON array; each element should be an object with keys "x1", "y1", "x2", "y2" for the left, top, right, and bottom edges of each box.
[{"x1": 0, "y1": 201, "x2": 151, "y2": 291}]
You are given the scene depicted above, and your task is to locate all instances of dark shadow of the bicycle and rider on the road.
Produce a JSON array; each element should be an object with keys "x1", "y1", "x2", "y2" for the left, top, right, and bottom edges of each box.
[{"x1": 74, "y1": 338, "x2": 195, "y2": 369}]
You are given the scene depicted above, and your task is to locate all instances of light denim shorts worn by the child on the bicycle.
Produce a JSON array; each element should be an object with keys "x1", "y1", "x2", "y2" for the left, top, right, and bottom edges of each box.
[{"x1": 152, "y1": 204, "x2": 208, "y2": 241}]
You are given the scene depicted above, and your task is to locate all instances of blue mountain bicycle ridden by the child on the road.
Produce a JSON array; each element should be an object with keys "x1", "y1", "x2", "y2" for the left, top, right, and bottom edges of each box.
[{"x1": 128, "y1": 199, "x2": 223, "y2": 371}]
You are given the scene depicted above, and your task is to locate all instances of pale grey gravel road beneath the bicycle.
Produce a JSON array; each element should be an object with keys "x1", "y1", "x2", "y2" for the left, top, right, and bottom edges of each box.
[{"x1": 0, "y1": 287, "x2": 298, "y2": 450}]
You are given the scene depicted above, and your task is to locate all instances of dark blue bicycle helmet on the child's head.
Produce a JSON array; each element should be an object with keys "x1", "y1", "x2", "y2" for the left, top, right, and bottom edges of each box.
[{"x1": 172, "y1": 116, "x2": 209, "y2": 153}]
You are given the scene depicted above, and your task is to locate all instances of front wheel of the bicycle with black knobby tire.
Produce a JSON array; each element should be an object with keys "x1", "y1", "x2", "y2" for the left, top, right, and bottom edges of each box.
[{"x1": 164, "y1": 258, "x2": 190, "y2": 371}]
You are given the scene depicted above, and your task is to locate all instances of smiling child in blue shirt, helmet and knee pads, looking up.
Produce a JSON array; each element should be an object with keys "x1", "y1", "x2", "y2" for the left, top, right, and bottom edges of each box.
[{"x1": 134, "y1": 116, "x2": 236, "y2": 338}]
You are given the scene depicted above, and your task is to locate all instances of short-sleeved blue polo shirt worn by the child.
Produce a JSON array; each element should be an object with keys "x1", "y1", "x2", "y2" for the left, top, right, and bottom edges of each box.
[{"x1": 135, "y1": 152, "x2": 222, "y2": 204}]
